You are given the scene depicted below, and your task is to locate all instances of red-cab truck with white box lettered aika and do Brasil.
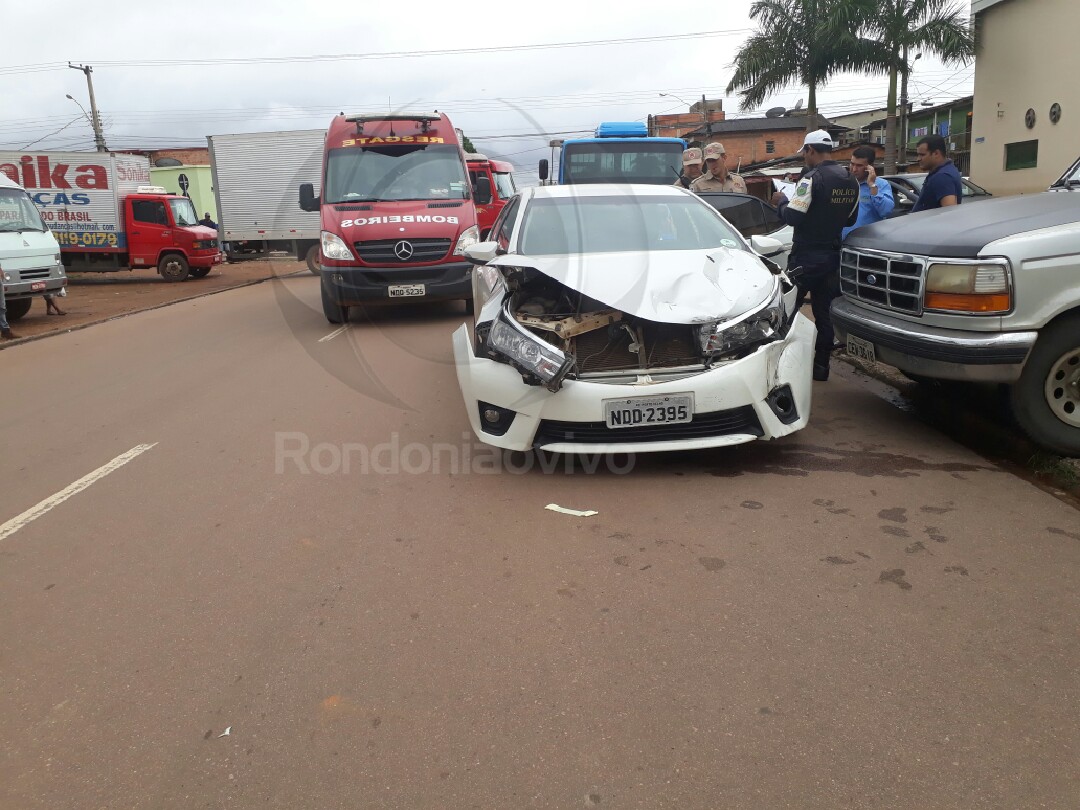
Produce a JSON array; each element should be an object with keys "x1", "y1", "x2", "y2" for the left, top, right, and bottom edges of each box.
[{"x1": 0, "y1": 151, "x2": 221, "y2": 281}]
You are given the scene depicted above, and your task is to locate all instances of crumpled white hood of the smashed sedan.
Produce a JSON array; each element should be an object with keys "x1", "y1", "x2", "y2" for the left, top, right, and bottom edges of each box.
[{"x1": 488, "y1": 247, "x2": 775, "y2": 324}]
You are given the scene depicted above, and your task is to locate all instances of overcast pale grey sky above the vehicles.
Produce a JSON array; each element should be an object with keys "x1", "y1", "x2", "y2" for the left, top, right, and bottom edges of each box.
[{"x1": 0, "y1": 0, "x2": 974, "y2": 184}]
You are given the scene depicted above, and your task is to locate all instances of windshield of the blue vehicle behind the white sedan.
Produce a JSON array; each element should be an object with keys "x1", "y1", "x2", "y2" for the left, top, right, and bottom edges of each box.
[{"x1": 563, "y1": 140, "x2": 683, "y2": 186}]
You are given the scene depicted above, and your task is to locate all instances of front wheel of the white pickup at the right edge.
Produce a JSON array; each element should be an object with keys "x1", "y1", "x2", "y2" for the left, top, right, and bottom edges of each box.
[{"x1": 1011, "y1": 313, "x2": 1080, "y2": 456}]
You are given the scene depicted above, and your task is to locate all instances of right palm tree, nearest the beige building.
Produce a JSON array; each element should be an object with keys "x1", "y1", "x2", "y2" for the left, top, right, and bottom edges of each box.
[{"x1": 863, "y1": 0, "x2": 975, "y2": 173}]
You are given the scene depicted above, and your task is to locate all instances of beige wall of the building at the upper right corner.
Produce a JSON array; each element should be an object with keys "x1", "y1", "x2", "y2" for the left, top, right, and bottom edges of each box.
[{"x1": 971, "y1": 0, "x2": 1080, "y2": 194}]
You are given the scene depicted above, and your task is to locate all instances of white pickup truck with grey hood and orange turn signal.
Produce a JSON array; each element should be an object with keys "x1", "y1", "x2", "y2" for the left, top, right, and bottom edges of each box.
[{"x1": 833, "y1": 161, "x2": 1080, "y2": 456}]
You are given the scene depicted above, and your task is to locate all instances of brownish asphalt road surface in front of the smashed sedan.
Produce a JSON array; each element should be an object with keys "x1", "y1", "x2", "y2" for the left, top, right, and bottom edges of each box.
[{"x1": 0, "y1": 276, "x2": 1080, "y2": 810}]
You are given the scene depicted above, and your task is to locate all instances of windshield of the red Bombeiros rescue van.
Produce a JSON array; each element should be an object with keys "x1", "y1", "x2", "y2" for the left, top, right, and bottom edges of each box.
[{"x1": 325, "y1": 144, "x2": 469, "y2": 204}]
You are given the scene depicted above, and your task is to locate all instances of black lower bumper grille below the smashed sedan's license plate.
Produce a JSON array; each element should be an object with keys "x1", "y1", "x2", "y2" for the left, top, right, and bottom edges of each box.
[{"x1": 532, "y1": 405, "x2": 765, "y2": 447}]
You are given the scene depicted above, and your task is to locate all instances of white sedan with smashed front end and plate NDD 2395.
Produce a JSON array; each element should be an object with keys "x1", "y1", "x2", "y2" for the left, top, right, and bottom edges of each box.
[{"x1": 454, "y1": 185, "x2": 815, "y2": 453}]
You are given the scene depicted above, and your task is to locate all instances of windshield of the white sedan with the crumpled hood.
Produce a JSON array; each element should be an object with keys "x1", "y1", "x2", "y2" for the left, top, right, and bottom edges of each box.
[{"x1": 518, "y1": 195, "x2": 746, "y2": 256}]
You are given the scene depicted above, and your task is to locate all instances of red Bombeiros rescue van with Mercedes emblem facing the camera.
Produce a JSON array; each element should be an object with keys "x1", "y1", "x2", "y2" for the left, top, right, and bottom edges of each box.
[{"x1": 300, "y1": 112, "x2": 479, "y2": 323}]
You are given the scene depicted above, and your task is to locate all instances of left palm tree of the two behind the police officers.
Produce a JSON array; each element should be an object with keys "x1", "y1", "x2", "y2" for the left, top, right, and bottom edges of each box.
[{"x1": 727, "y1": 0, "x2": 883, "y2": 132}]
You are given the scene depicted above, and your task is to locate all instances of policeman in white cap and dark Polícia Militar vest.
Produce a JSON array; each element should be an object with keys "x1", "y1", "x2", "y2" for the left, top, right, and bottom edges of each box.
[{"x1": 772, "y1": 130, "x2": 859, "y2": 382}]
